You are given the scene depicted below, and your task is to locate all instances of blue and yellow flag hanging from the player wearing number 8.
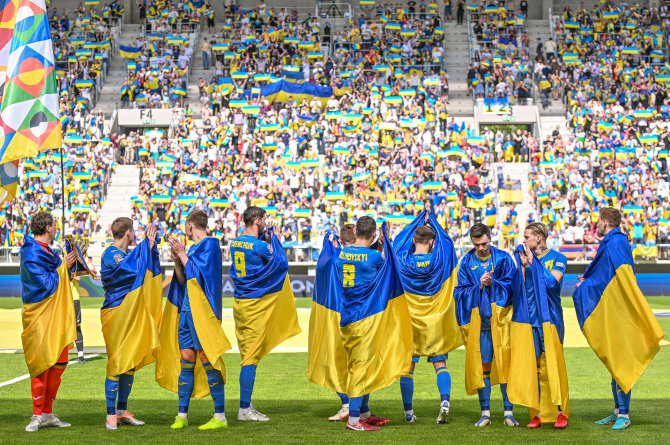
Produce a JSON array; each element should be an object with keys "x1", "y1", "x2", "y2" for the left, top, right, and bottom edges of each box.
[{"x1": 344, "y1": 222, "x2": 412, "y2": 397}]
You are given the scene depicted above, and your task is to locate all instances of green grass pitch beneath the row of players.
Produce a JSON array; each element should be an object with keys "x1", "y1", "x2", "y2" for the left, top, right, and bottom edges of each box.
[{"x1": 0, "y1": 298, "x2": 670, "y2": 444}]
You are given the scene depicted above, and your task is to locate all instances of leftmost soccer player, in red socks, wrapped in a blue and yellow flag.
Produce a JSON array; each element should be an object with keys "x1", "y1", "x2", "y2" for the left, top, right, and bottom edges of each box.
[{"x1": 21, "y1": 211, "x2": 77, "y2": 432}]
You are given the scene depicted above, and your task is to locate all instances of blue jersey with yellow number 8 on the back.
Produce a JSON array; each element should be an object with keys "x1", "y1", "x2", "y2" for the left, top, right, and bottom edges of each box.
[{"x1": 337, "y1": 246, "x2": 384, "y2": 299}]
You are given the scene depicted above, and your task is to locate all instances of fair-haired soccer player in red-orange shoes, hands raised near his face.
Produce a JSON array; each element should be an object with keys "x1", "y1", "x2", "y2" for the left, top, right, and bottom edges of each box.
[{"x1": 519, "y1": 222, "x2": 568, "y2": 429}]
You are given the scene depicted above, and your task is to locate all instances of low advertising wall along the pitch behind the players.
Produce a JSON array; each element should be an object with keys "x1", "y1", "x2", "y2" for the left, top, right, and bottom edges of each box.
[{"x1": 0, "y1": 263, "x2": 670, "y2": 298}]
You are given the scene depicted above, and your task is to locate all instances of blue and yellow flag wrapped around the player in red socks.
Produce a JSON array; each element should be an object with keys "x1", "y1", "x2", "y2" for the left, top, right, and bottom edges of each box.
[{"x1": 21, "y1": 236, "x2": 77, "y2": 377}]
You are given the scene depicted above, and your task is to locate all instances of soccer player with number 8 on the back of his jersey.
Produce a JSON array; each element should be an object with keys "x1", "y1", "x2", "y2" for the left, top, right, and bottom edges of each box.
[{"x1": 337, "y1": 216, "x2": 392, "y2": 431}]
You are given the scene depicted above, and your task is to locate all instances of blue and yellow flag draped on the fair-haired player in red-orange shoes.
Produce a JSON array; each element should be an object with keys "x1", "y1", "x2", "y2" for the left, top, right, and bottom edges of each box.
[{"x1": 507, "y1": 246, "x2": 570, "y2": 422}]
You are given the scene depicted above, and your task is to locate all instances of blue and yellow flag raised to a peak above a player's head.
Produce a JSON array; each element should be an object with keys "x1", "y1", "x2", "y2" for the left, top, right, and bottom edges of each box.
[{"x1": 393, "y1": 210, "x2": 463, "y2": 357}]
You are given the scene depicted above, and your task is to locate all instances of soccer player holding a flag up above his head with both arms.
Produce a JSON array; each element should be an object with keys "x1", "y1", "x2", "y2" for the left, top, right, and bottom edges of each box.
[{"x1": 394, "y1": 225, "x2": 456, "y2": 424}]
